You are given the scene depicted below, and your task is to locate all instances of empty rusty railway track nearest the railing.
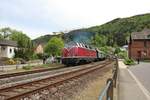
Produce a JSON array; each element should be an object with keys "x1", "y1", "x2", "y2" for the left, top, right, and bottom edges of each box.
[{"x1": 0, "y1": 61, "x2": 112, "y2": 100}]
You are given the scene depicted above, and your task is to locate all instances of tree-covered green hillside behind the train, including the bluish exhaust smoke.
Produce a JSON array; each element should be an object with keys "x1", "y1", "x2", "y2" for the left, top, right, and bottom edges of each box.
[{"x1": 34, "y1": 13, "x2": 150, "y2": 46}]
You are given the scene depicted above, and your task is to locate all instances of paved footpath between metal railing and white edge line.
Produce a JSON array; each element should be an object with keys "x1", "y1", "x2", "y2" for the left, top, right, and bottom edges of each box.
[{"x1": 118, "y1": 61, "x2": 150, "y2": 100}]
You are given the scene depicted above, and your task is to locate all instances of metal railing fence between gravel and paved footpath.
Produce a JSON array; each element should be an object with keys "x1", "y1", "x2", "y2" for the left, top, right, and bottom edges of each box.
[{"x1": 99, "y1": 58, "x2": 118, "y2": 100}]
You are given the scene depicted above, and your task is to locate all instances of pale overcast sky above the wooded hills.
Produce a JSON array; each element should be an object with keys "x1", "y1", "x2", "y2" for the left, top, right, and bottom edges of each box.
[{"x1": 0, "y1": 0, "x2": 150, "y2": 39}]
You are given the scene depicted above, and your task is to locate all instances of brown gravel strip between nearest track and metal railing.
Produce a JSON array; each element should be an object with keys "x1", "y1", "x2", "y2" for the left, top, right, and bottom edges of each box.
[{"x1": 27, "y1": 62, "x2": 112, "y2": 100}]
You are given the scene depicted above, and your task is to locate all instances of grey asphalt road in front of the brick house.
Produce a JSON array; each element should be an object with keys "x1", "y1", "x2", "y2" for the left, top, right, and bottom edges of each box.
[{"x1": 129, "y1": 62, "x2": 150, "y2": 92}]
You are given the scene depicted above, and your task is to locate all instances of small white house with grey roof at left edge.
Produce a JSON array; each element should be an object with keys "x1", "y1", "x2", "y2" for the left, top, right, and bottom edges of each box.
[{"x1": 0, "y1": 40, "x2": 17, "y2": 58}]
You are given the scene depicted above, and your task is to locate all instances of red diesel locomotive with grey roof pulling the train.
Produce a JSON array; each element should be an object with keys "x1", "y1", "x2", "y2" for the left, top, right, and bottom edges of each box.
[{"x1": 62, "y1": 43, "x2": 105, "y2": 65}]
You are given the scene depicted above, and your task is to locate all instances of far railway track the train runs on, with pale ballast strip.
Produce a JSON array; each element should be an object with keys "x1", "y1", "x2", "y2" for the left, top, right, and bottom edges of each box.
[{"x1": 0, "y1": 61, "x2": 108, "y2": 86}]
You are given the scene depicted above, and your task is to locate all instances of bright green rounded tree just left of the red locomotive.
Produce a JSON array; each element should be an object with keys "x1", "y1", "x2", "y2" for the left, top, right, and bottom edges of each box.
[{"x1": 44, "y1": 37, "x2": 64, "y2": 56}]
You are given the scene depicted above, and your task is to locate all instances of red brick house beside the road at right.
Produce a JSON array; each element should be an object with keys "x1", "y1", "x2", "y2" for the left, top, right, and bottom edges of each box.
[{"x1": 128, "y1": 29, "x2": 150, "y2": 60}]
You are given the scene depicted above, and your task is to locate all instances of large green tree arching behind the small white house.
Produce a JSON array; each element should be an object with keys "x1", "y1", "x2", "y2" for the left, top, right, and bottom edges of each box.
[{"x1": 0, "y1": 27, "x2": 33, "y2": 60}]
